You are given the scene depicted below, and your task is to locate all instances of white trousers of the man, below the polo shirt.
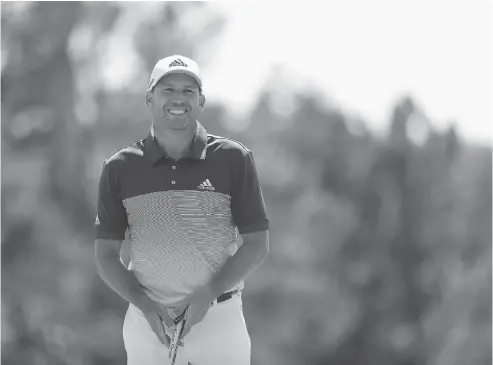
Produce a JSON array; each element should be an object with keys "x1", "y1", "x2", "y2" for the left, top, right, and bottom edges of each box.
[{"x1": 123, "y1": 295, "x2": 251, "y2": 365}]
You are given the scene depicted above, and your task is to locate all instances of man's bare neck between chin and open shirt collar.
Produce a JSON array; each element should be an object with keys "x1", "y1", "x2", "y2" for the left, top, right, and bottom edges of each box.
[{"x1": 152, "y1": 122, "x2": 197, "y2": 160}]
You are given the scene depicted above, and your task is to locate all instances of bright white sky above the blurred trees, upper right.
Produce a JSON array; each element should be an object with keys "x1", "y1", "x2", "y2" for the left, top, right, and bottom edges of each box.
[{"x1": 100, "y1": 1, "x2": 493, "y2": 144}]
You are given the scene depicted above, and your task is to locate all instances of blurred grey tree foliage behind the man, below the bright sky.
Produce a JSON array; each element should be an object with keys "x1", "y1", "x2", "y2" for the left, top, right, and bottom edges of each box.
[{"x1": 1, "y1": 2, "x2": 492, "y2": 365}]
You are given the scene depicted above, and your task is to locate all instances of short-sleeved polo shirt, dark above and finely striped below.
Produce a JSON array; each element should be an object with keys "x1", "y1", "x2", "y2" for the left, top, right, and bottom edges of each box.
[{"x1": 95, "y1": 122, "x2": 269, "y2": 306}]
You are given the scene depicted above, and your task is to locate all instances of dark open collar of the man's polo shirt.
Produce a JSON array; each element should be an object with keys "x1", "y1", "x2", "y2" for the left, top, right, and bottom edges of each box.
[{"x1": 144, "y1": 122, "x2": 207, "y2": 165}]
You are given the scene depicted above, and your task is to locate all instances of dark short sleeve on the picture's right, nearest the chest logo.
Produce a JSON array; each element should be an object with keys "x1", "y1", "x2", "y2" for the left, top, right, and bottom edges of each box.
[{"x1": 231, "y1": 152, "x2": 269, "y2": 234}]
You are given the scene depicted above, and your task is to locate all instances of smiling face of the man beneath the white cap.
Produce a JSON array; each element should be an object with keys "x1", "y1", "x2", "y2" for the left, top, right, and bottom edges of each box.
[{"x1": 146, "y1": 74, "x2": 205, "y2": 132}]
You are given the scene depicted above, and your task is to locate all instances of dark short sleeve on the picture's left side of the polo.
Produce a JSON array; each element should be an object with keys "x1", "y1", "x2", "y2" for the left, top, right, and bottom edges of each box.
[{"x1": 95, "y1": 161, "x2": 128, "y2": 241}]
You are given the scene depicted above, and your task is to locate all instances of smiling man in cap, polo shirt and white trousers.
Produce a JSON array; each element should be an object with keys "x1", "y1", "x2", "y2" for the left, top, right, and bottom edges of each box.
[{"x1": 95, "y1": 55, "x2": 269, "y2": 365}]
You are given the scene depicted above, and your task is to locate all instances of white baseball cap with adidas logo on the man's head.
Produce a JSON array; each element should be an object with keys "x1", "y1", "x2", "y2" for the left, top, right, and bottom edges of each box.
[{"x1": 148, "y1": 55, "x2": 202, "y2": 90}]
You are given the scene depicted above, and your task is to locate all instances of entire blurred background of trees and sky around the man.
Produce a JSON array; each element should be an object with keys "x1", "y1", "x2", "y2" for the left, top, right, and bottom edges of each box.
[{"x1": 1, "y1": 2, "x2": 493, "y2": 365}]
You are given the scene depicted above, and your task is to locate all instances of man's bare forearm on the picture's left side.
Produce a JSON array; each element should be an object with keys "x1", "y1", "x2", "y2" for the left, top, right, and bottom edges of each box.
[{"x1": 96, "y1": 243, "x2": 150, "y2": 308}]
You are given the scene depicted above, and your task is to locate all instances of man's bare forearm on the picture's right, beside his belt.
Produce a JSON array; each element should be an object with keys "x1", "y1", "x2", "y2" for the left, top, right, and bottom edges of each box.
[{"x1": 209, "y1": 231, "x2": 269, "y2": 297}]
